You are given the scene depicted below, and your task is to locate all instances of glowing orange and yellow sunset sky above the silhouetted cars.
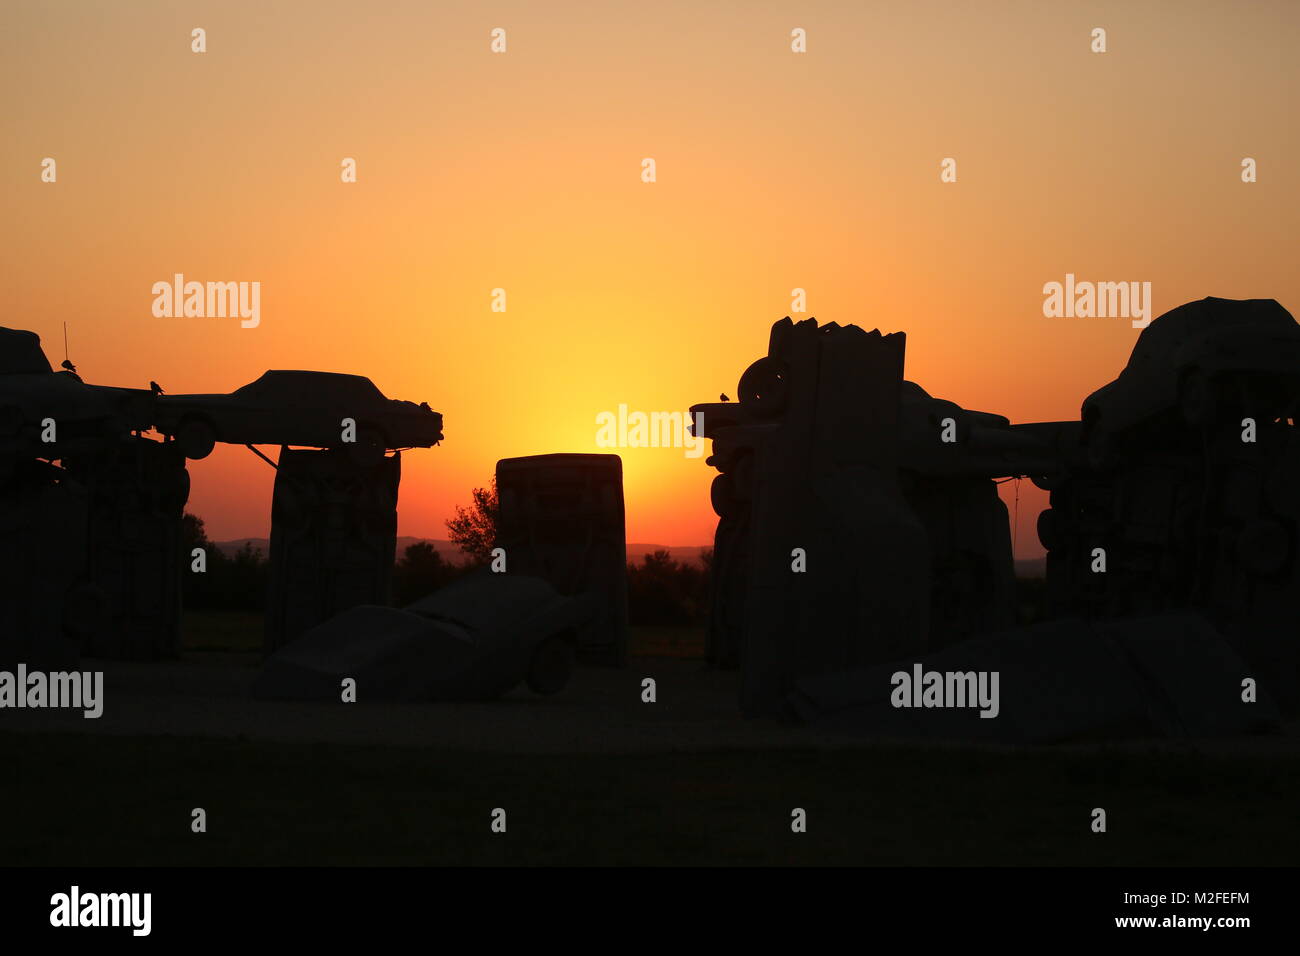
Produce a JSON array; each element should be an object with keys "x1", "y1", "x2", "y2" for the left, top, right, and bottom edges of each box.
[{"x1": 0, "y1": 0, "x2": 1300, "y2": 555}]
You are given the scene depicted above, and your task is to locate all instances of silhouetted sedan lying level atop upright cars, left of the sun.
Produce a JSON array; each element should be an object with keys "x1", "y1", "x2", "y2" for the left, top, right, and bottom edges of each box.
[{"x1": 155, "y1": 371, "x2": 442, "y2": 463}]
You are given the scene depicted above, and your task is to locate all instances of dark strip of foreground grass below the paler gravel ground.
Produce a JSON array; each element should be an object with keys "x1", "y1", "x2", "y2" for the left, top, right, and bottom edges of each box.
[{"x1": 0, "y1": 734, "x2": 1300, "y2": 866}]
